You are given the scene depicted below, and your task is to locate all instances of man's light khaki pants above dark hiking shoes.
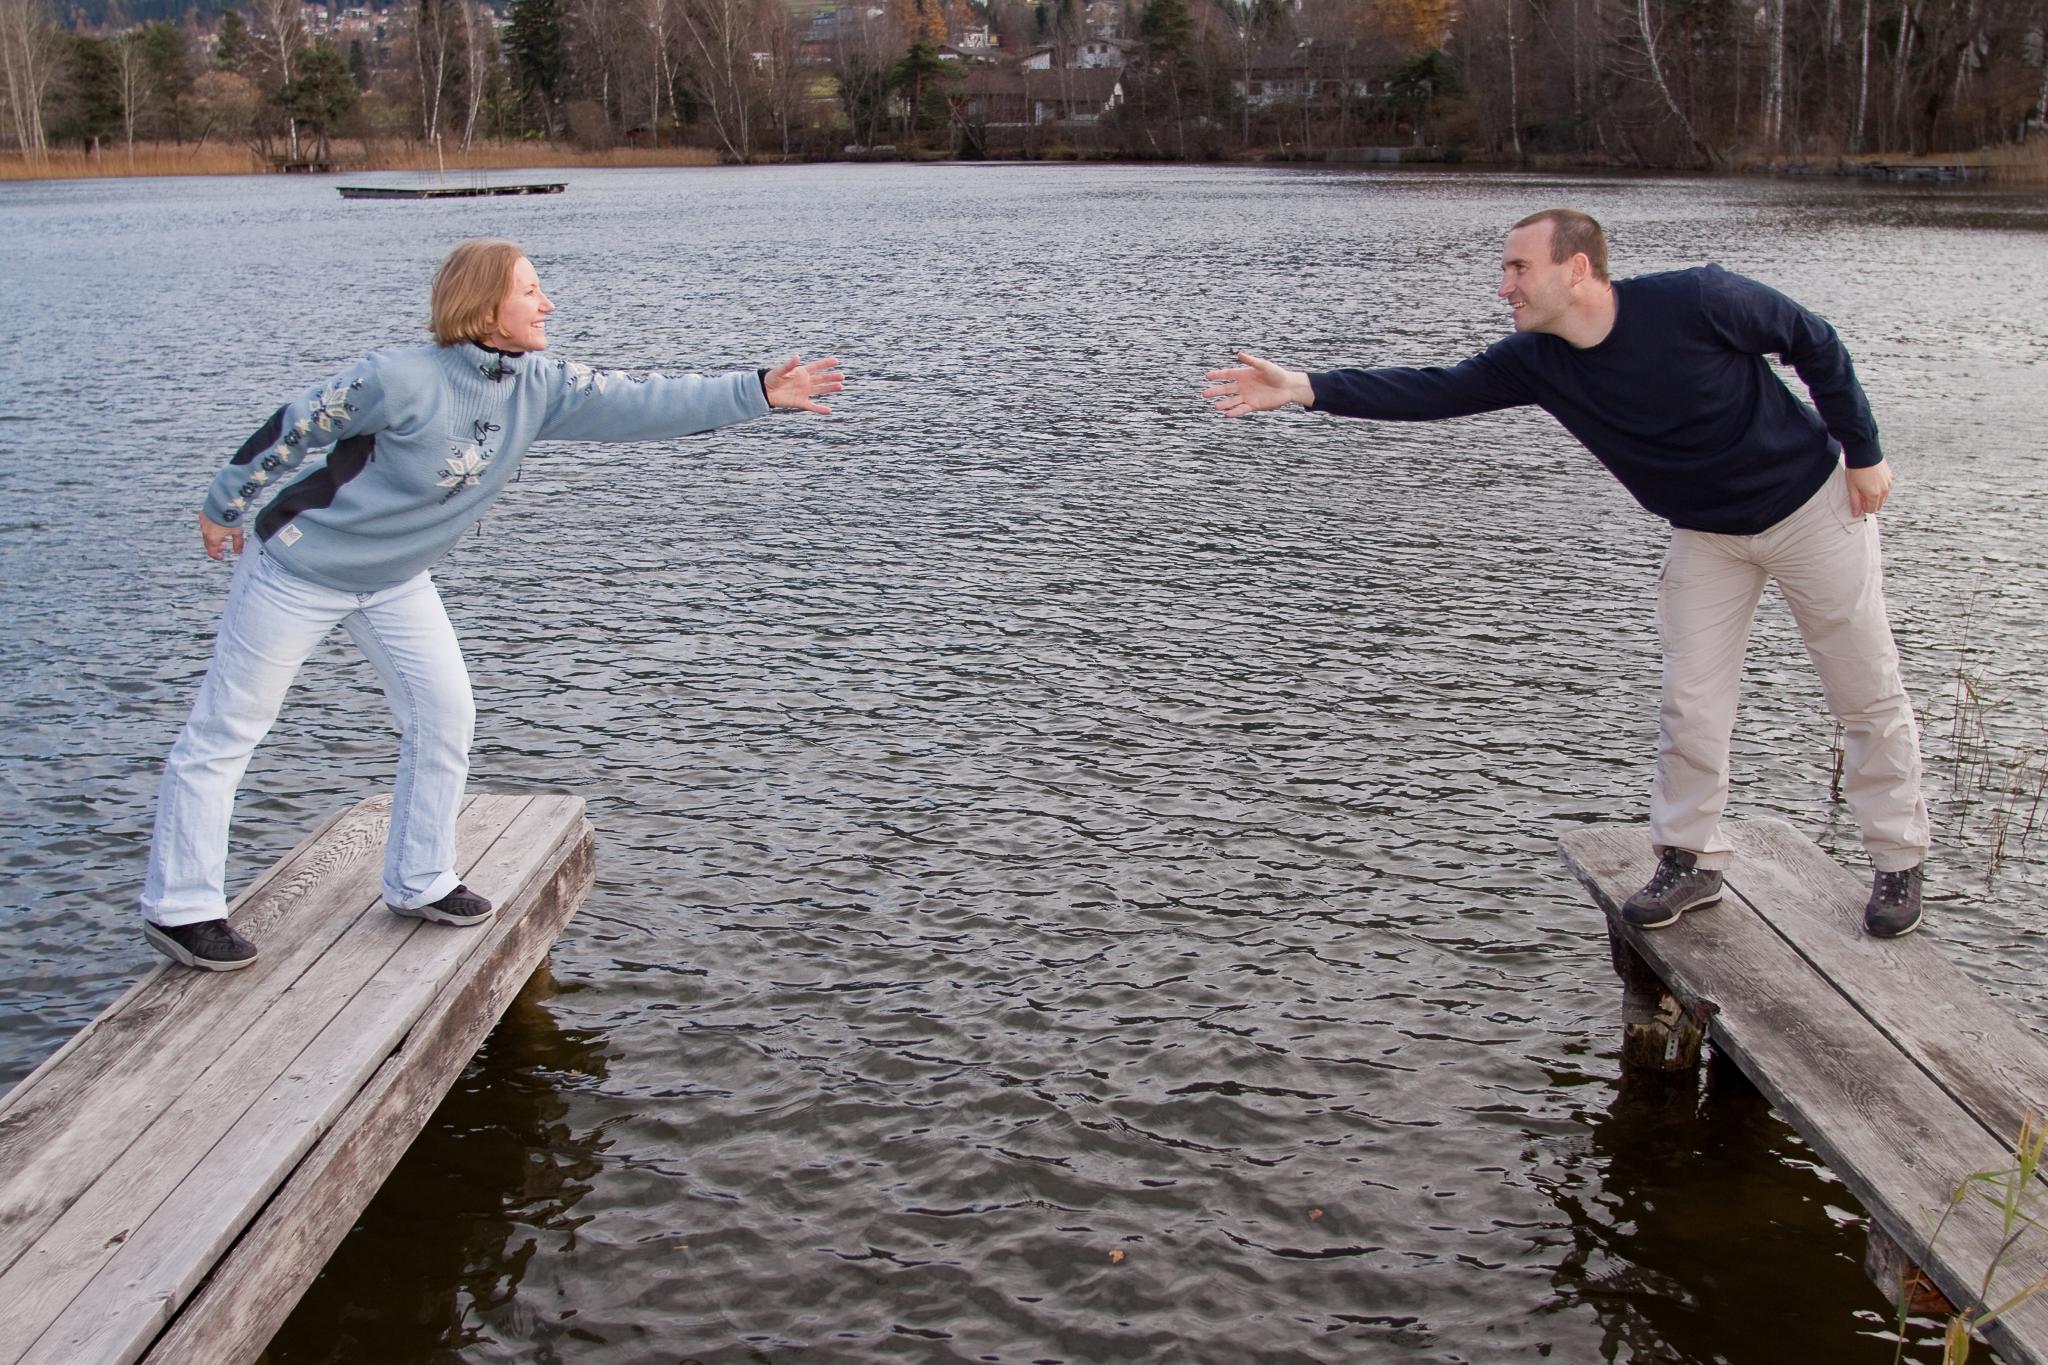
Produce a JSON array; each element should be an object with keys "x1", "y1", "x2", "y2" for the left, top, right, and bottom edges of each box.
[{"x1": 1651, "y1": 469, "x2": 1927, "y2": 872}]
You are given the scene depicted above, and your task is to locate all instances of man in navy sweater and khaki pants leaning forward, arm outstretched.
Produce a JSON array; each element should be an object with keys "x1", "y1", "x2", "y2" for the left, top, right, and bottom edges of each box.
[{"x1": 1202, "y1": 209, "x2": 1929, "y2": 937}]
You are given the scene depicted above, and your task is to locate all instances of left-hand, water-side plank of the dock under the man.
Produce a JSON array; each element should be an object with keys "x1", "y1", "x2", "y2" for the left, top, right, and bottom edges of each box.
[{"x1": 1565, "y1": 829, "x2": 2048, "y2": 1365}]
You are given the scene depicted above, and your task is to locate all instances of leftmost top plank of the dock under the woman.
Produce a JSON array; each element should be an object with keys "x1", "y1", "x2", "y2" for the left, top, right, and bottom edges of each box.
[{"x1": 0, "y1": 800, "x2": 389, "y2": 1285}]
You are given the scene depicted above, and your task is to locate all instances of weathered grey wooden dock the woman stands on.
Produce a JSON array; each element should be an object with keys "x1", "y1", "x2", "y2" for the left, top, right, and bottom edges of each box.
[{"x1": 0, "y1": 796, "x2": 596, "y2": 1365}]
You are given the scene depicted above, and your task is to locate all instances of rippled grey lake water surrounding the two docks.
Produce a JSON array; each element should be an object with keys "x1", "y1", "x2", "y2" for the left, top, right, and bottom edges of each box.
[{"x1": 0, "y1": 166, "x2": 2048, "y2": 1365}]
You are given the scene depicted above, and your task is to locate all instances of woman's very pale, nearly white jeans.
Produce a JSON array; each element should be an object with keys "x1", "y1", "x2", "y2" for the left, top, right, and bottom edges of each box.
[{"x1": 141, "y1": 540, "x2": 477, "y2": 925}]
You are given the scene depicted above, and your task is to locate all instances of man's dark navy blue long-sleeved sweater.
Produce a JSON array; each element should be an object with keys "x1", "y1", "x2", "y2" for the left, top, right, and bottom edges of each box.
[{"x1": 1309, "y1": 266, "x2": 1884, "y2": 536}]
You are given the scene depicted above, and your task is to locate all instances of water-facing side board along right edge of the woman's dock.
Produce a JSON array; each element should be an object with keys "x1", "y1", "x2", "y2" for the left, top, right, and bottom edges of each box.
[{"x1": 145, "y1": 798, "x2": 596, "y2": 1365}]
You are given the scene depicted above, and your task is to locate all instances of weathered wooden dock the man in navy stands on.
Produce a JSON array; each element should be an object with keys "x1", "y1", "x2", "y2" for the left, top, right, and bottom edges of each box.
[{"x1": 1563, "y1": 821, "x2": 2048, "y2": 1365}]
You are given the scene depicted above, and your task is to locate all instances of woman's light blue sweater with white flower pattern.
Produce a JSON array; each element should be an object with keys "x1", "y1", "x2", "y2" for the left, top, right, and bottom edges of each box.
[{"x1": 203, "y1": 342, "x2": 768, "y2": 591}]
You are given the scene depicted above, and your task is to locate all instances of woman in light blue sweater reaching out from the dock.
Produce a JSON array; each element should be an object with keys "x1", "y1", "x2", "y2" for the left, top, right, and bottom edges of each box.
[{"x1": 141, "y1": 239, "x2": 842, "y2": 972}]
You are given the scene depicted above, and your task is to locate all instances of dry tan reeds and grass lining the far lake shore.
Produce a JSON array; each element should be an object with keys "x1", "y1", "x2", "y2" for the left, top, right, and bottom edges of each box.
[{"x1": 0, "y1": 139, "x2": 2048, "y2": 188}]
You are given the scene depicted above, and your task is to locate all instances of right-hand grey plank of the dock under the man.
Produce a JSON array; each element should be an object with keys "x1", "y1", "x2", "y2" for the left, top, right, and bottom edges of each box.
[{"x1": 1729, "y1": 819, "x2": 2048, "y2": 1144}]
